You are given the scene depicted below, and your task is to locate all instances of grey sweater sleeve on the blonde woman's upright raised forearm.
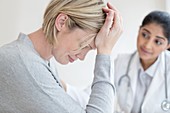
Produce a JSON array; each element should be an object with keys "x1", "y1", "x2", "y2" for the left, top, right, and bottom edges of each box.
[{"x1": 87, "y1": 55, "x2": 114, "y2": 113}]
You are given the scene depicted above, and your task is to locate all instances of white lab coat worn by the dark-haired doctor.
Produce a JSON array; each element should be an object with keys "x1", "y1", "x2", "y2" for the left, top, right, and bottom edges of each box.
[{"x1": 67, "y1": 51, "x2": 170, "y2": 113}]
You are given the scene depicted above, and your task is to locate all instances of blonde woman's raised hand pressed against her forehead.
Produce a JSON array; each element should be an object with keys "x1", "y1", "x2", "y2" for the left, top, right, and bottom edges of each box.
[{"x1": 95, "y1": 3, "x2": 123, "y2": 54}]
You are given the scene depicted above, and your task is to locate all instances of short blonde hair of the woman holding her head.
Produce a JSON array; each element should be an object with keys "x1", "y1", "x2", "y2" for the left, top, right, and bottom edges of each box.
[{"x1": 42, "y1": 0, "x2": 105, "y2": 45}]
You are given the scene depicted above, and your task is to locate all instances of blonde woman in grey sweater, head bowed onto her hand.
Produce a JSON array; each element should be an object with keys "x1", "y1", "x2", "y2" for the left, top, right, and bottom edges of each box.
[{"x1": 0, "y1": 0, "x2": 122, "y2": 113}]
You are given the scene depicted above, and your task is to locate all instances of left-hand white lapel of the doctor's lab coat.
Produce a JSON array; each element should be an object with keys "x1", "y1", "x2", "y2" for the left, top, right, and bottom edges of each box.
[{"x1": 127, "y1": 52, "x2": 139, "y2": 113}]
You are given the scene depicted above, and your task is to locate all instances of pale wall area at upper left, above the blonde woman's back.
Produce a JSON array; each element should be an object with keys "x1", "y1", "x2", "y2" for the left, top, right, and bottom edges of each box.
[{"x1": 0, "y1": 0, "x2": 50, "y2": 46}]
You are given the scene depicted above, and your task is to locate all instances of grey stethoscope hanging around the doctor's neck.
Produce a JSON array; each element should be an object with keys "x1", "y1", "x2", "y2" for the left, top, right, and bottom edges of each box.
[{"x1": 118, "y1": 52, "x2": 170, "y2": 112}]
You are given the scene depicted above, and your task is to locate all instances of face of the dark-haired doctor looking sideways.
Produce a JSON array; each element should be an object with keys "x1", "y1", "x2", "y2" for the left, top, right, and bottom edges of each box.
[{"x1": 137, "y1": 23, "x2": 168, "y2": 63}]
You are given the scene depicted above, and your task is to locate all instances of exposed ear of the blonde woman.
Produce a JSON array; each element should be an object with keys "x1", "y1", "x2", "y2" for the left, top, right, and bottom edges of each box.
[{"x1": 55, "y1": 13, "x2": 68, "y2": 31}]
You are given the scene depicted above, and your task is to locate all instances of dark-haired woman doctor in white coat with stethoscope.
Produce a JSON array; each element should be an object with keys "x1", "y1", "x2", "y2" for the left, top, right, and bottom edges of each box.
[{"x1": 63, "y1": 11, "x2": 170, "y2": 113}]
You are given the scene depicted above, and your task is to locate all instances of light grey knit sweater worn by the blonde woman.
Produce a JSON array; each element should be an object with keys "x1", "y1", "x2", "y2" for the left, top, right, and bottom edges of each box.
[{"x1": 0, "y1": 34, "x2": 114, "y2": 113}]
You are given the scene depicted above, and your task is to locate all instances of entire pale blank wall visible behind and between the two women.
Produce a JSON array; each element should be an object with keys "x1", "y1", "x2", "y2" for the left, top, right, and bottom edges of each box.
[{"x1": 0, "y1": 0, "x2": 167, "y2": 87}]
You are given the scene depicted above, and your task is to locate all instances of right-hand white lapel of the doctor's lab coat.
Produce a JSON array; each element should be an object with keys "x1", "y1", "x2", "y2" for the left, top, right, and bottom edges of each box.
[{"x1": 142, "y1": 53, "x2": 165, "y2": 111}]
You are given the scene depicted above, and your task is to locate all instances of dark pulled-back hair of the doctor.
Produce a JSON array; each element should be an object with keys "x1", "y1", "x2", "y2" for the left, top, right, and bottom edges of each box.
[{"x1": 141, "y1": 11, "x2": 170, "y2": 43}]
